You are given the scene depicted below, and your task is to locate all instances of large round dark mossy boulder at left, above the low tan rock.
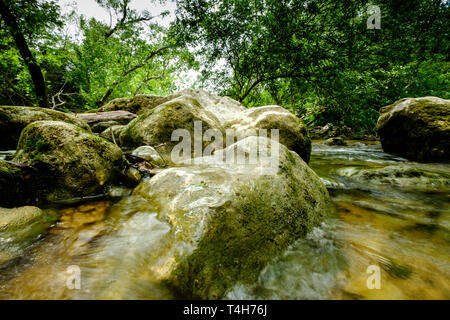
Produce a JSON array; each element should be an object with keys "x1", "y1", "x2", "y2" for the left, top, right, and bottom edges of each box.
[{"x1": 13, "y1": 121, "x2": 124, "y2": 201}]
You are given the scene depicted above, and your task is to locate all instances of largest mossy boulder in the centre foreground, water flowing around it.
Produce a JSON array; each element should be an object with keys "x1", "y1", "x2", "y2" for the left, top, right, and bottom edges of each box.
[{"x1": 126, "y1": 137, "x2": 330, "y2": 299}]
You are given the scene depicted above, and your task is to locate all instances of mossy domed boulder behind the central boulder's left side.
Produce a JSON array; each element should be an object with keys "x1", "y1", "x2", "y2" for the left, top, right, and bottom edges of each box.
[{"x1": 119, "y1": 96, "x2": 223, "y2": 163}]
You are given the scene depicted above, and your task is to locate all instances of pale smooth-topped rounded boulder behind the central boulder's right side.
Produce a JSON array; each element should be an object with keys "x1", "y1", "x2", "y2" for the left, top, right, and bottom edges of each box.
[{"x1": 224, "y1": 106, "x2": 311, "y2": 163}]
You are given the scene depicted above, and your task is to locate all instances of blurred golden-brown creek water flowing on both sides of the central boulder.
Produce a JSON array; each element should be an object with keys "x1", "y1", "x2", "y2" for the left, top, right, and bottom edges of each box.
[{"x1": 0, "y1": 141, "x2": 450, "y2": 299}]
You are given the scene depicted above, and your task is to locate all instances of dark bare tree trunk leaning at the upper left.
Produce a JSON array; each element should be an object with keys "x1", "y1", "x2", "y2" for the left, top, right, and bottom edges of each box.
[{"x1": 0, "y1": 0, "x2": 50, "y2": 108}]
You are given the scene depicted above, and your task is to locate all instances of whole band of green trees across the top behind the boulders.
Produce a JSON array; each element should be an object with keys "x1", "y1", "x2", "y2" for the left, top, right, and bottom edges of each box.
[{"x1": 0, "y1": 0, "x2": 450, "y2": 130}]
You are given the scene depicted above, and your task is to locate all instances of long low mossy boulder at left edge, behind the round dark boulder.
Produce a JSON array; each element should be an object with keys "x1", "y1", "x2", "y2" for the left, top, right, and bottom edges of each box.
[{"x1": 0, "y1": 106, "x2": 90, "y2": 150}]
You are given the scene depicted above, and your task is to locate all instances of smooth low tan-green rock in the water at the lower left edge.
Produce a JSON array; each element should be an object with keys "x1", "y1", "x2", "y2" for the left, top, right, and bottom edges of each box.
[{"x1": 0, "y1": 207, "x2": 58, "y2": 265}]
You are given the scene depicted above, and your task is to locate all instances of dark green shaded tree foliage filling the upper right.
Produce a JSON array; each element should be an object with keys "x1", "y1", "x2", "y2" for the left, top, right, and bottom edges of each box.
[{"x1": 172, "y1": 0, "x2": 450, "y2": 131}]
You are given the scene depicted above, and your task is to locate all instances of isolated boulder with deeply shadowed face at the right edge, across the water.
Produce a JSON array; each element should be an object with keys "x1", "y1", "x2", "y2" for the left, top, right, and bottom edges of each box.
[{"x1": 377, "y1": 97, "x2": 450, "y2": 162}]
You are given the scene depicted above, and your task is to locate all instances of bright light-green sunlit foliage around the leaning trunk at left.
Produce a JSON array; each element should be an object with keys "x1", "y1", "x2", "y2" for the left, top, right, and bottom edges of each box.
[{"x1": 0, "y1": 0, "x2": 195, "y2": 111}]
